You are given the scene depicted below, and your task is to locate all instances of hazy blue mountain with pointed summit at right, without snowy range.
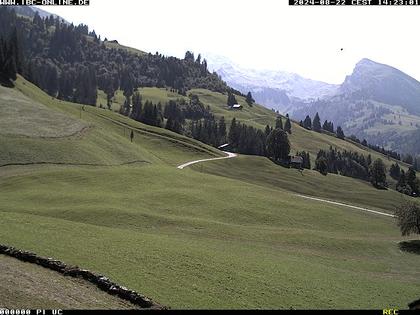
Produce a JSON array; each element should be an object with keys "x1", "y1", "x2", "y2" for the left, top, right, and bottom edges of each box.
[{"x1": 291, "y1": 59, "x2": 420, "y2": 154}]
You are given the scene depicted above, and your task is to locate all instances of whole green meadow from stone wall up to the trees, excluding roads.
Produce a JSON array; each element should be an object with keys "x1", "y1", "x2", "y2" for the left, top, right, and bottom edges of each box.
[{"x1": 0, "y1": 79, "x2": 420, "y2": 309}]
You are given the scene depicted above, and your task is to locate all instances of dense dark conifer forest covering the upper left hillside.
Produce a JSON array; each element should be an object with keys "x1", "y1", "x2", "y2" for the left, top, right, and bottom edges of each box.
[{"x1": 0, "y1": 7, "x2": 242, "y2": 106}]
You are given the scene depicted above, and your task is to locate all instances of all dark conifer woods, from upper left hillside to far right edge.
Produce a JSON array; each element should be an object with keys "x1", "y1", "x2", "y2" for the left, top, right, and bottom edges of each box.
[{"x1": 0, "y1": 7, "x2": 419, "y2": 196}]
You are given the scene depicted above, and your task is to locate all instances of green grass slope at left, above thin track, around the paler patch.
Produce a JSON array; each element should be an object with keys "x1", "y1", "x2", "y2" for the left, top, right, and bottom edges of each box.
[{"x1": 0, "y1": 78, "x2": 221, "y2": 166}]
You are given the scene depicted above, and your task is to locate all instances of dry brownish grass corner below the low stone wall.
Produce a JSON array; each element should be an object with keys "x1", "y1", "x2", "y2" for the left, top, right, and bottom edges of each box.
[{"x1": 0, "y1": 255, "x2": 135, "y2": 309}]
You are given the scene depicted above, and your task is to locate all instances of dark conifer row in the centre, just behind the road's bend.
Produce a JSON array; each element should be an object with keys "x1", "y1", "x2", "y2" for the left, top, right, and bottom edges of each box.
[{"x1": 116, "y1": 91, "x2": 296, "y2": 162}]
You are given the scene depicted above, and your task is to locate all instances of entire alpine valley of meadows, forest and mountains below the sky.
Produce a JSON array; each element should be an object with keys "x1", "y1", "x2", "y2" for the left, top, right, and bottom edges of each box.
[{"x1": 0, "y1": 7, "x2": 420, "y2": 310}]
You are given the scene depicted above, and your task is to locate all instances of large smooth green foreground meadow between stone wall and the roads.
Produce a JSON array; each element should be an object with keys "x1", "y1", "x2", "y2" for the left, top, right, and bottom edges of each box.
[{"x1": 0, "y1": 165, "x2": 420, "y2": 308}]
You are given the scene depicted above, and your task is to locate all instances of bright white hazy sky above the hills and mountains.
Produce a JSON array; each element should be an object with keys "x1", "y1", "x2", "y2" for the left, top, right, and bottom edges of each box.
[{"x1": 42, "y1": 0, "x2": 420, "y2": 83}]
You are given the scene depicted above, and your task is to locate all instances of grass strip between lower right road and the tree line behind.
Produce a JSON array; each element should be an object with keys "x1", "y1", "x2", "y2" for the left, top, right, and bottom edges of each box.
[{"x1": 192, "y1": 155, "x2": 410, "y2": 213}]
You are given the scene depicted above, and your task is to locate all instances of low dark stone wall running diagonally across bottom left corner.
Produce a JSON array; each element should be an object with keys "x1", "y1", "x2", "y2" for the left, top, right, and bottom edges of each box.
[{"x1": 0, "y1": 244, "x2": 167, "y2": 309}]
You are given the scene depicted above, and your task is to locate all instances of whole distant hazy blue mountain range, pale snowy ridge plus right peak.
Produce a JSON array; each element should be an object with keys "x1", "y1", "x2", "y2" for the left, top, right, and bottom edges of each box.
[{"x1": 206, "y1": 55, "x2": 420, "y2": 154}]
